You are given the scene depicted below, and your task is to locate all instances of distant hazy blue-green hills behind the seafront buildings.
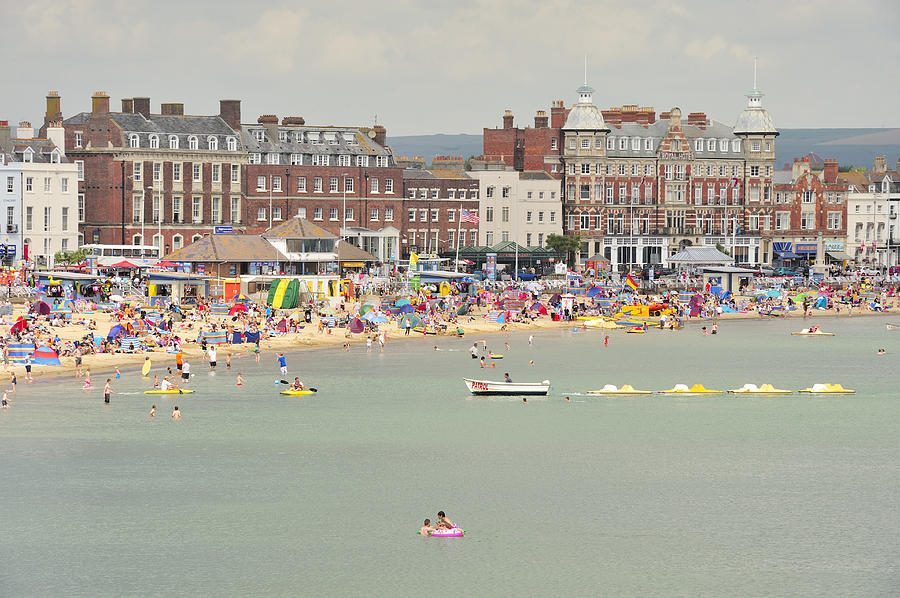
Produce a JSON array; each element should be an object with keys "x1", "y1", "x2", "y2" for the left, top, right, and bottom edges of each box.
[{"x1": 388, "y1": 129, "x2": 900, "y2": 168}]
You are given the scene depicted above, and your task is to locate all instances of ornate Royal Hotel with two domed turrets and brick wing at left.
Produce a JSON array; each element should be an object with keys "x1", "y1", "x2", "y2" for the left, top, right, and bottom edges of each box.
[{"x1": 484, "y1": 79, "x2": 778, "y2": 267}]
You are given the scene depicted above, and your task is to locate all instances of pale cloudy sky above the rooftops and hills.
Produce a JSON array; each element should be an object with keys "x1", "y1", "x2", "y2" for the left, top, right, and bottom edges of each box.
[{"x1": 0, "y1": 0, "x2": 900, "y2": 136}]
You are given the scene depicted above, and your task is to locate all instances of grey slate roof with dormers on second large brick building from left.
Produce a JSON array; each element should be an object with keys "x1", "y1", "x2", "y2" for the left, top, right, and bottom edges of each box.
[{"x1": 241, "y1": 123, "x2": 396, "y2": 166}]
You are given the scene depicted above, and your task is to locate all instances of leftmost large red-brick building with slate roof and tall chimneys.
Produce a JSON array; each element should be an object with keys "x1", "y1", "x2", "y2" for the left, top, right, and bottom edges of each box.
[{"x1": 49, "y1": 91, "x2": 247, "y2": 253}]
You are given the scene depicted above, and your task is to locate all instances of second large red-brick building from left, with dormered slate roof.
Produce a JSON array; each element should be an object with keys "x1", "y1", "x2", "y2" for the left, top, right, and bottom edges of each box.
[{"x1": 241, "y1": 115, "x2": 403, "y2": 261}]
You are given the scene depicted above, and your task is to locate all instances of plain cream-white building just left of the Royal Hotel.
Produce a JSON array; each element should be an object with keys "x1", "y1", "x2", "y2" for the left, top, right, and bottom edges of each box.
[{"x1": 468, "y1": 169, "x2": 562, "y2": 247}]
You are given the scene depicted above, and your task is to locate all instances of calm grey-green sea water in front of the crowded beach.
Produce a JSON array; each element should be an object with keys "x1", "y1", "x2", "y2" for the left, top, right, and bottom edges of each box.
[{"x1": 0, "y1": 318, "x2": 900, "y2": 596}]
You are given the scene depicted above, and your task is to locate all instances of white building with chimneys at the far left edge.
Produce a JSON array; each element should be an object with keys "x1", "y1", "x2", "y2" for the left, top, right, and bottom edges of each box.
[{"x1": 0, "y1": 122, "x2": 79, "y2": 268}]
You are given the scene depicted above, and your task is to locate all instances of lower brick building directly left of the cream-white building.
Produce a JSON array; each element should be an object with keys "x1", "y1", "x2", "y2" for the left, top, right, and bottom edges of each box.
[{"x1": 402, "y1": 168, "x2": 478, "y2": 256}]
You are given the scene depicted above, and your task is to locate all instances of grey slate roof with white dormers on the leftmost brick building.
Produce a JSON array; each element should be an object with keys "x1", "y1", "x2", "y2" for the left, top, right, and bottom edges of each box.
[{"x1": 63, "y1": 112, "x2": 243, "y2": 152}]
